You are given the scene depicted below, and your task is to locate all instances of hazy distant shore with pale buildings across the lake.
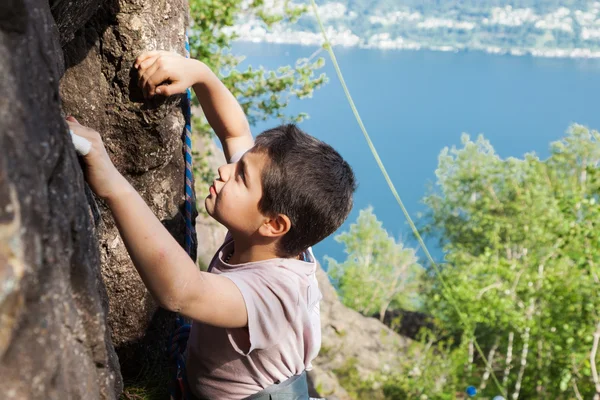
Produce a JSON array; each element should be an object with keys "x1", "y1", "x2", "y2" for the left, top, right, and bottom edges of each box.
[{"x1": 226, "y1": 0, "x2": 600, "y2": 59}]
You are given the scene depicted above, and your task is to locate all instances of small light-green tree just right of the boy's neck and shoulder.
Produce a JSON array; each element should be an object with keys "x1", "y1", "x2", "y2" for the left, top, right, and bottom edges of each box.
[{"x1": 326, "y1": 207, "x2": 422, "y2": 320}]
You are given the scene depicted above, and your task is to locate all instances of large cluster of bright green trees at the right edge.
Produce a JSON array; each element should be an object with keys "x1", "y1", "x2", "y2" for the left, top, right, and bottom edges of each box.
[{"x1": 424, "y1": 125, "x2": 600, "y2": 399}]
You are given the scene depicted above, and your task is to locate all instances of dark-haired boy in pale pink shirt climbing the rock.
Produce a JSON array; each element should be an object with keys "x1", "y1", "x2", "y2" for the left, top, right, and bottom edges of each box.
[{"x1": 67, "y1": 51, "x2": 356, "y2": 399}]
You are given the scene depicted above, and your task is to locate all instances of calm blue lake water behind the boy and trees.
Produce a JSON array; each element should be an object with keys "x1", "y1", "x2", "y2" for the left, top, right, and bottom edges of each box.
[{"x1": 233, "y1": 42, "x2": 600, "y2": 267}]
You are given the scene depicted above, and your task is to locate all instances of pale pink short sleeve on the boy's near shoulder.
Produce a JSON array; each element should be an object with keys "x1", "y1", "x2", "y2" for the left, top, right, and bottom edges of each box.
[{"x1": 222, "y1": 267, "x2": 300, "y2": 355}]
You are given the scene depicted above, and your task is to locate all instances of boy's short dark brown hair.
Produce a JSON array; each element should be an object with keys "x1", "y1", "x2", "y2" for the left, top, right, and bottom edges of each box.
[{"x1": 252, "y1": 125, "x2": 356, "y2": 257}]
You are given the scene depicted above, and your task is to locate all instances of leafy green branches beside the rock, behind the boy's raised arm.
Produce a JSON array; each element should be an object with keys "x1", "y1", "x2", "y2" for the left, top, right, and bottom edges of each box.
[{"x1": 189, "y1": 0, "x2": 327, "y2": 128}]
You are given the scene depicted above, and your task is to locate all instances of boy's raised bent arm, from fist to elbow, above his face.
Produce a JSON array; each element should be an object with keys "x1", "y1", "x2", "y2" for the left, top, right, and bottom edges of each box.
[{"x1": 135, "y1": 51, "x2": 254, "y2": 160}]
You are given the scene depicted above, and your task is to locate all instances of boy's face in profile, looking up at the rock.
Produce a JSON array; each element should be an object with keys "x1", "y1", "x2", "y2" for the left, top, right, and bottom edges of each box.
[{"x1": 204, "y1": 151, "x2": 267, "y2": 237}]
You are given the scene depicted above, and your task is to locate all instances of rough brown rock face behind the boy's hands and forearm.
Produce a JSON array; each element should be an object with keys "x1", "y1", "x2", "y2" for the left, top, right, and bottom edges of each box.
[{"x1": 60, "y1": 0, "x2": 195, "y2": 376}]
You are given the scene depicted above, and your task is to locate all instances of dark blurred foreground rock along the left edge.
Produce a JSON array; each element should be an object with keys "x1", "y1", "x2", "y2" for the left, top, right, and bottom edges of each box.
[{"x1": 0, "y1": 0, "x2": 122, "y2": 399}]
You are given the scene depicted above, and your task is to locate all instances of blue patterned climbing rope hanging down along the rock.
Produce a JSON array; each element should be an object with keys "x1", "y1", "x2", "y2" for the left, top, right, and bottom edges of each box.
[{"x1": 168, "y1": 34, "x2": 194, "y2": 400}]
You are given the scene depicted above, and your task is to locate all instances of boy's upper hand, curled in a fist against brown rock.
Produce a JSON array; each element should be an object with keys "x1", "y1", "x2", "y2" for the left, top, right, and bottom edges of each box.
[{"x1": 135, "y1": 50, "x2": 202, "y2": 98}]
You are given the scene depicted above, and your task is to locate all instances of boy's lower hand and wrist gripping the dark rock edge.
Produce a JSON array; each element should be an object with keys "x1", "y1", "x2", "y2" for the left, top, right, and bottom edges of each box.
[{"x1": 67, "y1": 117, "x2": 131, "y2": 200}]
